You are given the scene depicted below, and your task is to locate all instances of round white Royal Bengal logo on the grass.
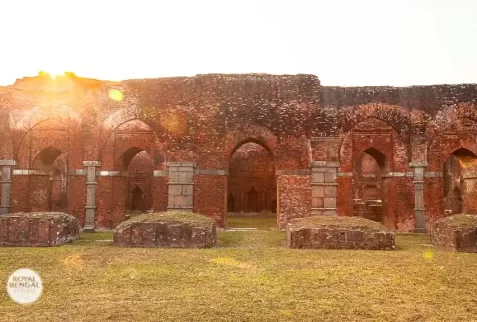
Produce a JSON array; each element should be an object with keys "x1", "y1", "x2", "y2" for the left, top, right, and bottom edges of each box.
[{"x1": 7, "y1": 268, "x2": 43, "y2": 304}]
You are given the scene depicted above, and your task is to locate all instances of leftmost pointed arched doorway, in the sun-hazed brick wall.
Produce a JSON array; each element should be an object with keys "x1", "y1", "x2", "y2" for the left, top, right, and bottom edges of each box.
[{"x1": 29, "y1": 146, "x2": 68, "y2": 211}]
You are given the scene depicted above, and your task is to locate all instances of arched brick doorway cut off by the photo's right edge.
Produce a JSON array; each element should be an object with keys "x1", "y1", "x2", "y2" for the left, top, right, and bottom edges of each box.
[{"x1": 443, "y1": 148, "x2": 477, "y2": 215}]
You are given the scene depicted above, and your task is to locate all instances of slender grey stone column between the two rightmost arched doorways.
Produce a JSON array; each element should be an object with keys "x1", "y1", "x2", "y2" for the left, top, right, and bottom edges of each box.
[{"x1": 409, "y1": 162, "x2": 427, "y2": 233}]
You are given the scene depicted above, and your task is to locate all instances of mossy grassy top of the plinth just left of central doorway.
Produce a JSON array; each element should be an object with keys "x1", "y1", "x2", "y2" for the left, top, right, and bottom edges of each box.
[{"x1": 116, "y1": 211, "x2": 214, "y2": 230}]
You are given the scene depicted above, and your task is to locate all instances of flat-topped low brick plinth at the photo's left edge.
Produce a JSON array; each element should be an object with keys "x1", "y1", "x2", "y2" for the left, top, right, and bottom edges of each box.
[{"x1": 0, "y1": 212, "x2": 79, "y2": 246}]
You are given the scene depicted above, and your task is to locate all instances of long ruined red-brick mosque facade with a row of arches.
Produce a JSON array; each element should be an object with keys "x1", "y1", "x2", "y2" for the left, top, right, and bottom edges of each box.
[{"x1": 0, "y1": 73, "x2": 477, "y2": 231}]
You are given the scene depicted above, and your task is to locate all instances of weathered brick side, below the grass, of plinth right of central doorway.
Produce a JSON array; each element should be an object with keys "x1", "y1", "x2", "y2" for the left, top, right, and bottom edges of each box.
[{"x1": 287, "y1": 219, "x2": 395, "y2": 250}]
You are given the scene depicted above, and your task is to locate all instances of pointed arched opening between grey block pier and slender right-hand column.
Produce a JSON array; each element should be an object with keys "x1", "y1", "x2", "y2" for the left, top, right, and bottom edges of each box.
[{"x1": 353, "y1": 148, "x2": 386, "y2": 222}]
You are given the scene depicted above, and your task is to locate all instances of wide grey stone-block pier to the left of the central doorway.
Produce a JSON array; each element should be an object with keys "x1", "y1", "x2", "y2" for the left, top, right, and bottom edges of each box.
[{"x1": 167, "y1": 162, "x2": 195, "y2": 211}]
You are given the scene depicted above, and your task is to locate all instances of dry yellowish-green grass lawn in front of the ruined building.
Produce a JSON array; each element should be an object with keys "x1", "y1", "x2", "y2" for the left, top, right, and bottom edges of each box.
[{"x1": 0, "y1": 219, "x2": 477, "y2": 321}]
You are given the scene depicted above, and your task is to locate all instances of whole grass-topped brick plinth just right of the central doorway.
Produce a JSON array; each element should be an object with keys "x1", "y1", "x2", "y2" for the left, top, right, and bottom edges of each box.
[{"x1": 287, "y1": 216, "x2": 395, "y2": 250}]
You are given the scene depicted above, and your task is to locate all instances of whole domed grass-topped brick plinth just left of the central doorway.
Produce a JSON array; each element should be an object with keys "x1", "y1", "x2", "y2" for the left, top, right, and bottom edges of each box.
[{"x1": 114, "y1": 211, "x2": 216, "y2": 248}]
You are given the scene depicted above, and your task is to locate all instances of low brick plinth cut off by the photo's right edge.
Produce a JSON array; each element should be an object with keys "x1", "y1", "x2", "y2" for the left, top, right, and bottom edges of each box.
[{"x1": 431, "y1": 214, "x2": 477, "y2": 253}]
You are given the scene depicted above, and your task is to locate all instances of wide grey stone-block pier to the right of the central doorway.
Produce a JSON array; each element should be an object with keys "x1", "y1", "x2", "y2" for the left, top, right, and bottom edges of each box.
[{"x1": 310, "y1": 161, "x2": 339, "y2": 216}]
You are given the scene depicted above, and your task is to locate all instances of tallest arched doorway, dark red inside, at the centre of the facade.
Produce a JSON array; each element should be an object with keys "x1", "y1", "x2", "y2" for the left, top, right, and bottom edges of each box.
[{"x1": 227, "y1": 141, "x2": 277, "y2": 228}]
